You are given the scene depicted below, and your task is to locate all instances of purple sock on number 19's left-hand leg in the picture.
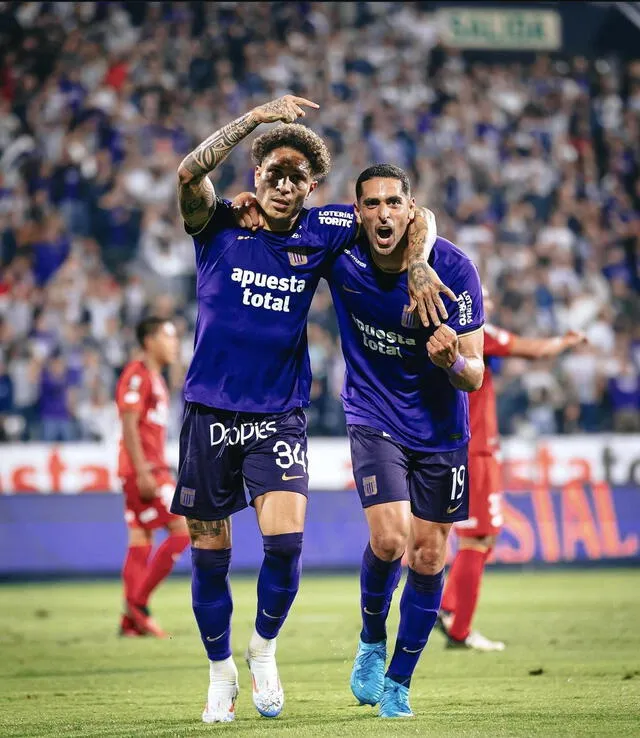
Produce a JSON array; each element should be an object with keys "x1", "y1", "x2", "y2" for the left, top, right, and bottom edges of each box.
[{"x1": 360, "y1": 543, "x2": 402, "y2": 643}]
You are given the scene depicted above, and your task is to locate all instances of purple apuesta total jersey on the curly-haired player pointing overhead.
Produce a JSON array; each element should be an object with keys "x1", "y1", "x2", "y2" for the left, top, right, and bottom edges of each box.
[{"x1": 184, "y1": 199, "x2": 357, "y2": 413}]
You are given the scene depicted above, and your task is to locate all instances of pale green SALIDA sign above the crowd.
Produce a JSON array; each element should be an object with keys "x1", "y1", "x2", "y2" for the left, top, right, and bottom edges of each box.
[{"x1": 436, "y1": 8, "x2": 562, "y2": 51}]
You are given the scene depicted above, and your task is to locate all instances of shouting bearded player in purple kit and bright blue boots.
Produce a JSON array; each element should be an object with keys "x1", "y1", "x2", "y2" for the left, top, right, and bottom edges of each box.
[{"x1": 327, "y1": 164, "x2": 484, "y2": 718}]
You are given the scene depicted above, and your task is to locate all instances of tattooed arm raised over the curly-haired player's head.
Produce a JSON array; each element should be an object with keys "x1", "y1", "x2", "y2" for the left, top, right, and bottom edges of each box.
[{"x1": 178, "y1": 95, "x2": 319, "y2": 230}]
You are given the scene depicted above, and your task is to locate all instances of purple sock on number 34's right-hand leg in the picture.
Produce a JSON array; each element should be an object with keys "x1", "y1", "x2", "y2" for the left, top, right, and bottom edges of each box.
[{"x1": 256, "y1": 533, "x2": 302, "y2": 639}]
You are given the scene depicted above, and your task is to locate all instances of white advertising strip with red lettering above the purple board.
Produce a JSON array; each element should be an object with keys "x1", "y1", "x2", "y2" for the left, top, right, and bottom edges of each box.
[{"x1": 0, "y1": 434, "x2": 640, "y2": 495}]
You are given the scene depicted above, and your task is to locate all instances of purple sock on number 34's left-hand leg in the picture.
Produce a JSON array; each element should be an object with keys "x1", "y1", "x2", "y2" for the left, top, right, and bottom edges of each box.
[{"x1": 191, "y1": 547, "x2": 233, "y2": 661}]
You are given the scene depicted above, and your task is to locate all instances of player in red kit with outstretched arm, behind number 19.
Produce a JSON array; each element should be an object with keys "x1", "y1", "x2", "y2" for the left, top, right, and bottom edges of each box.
[{"x1": 439, "y1": 290, "x2": 586, "y2": 651}]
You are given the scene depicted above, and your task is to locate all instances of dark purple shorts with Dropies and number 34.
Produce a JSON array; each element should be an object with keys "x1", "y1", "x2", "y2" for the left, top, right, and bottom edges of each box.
[{"x1": 171, "y1": 402, "x2": 309, "y2": 520}]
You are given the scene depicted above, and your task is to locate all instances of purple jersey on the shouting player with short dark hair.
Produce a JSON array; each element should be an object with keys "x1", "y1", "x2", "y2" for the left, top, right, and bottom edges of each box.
[{"x1": 329, "y1": 238, "x2": 484, "y2": 452}]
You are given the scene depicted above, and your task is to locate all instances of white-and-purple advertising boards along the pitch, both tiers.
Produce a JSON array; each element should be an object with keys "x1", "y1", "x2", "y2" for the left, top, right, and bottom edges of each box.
[{"x1": 0, "y1": 436, "x2": 640, "y2": 577}]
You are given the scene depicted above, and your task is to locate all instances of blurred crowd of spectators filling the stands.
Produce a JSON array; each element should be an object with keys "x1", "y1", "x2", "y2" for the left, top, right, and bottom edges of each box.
[{"x1": 0, "y1": 2, "x2": 640, "y2": 441}]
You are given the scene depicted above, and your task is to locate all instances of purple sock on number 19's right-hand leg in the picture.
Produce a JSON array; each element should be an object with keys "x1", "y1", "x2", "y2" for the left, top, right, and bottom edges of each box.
[{"x1": 387, "y1": 569, "x2": 444, "y2": 687}]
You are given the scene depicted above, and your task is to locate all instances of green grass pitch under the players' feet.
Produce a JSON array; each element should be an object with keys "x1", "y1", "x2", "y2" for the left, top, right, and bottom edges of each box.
[{"x1": 0, "y1": 569, "x2": 640, "y2": 738}]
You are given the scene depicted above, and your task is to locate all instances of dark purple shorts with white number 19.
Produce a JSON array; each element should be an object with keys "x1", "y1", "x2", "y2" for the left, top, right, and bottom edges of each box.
[{"x1": 347, "y1": 425, "x2": 469, "y2": 523}]
